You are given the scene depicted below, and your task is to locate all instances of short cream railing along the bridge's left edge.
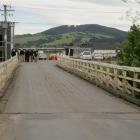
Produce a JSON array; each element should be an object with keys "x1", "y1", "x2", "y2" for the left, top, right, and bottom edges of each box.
[{"x1": 0, "y1": 57, "x2": 18, "y2": 97}]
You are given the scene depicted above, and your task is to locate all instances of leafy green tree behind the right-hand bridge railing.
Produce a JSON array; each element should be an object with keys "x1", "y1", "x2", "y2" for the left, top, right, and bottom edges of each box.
[{"x1": 119, "y1": 24, "x2": 140, "y2": 67}]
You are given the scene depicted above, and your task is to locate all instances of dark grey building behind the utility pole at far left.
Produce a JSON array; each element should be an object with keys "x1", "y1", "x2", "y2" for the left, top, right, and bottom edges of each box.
[{"x1": 0, "y1": 22, "x2": 14, "y2": 61}]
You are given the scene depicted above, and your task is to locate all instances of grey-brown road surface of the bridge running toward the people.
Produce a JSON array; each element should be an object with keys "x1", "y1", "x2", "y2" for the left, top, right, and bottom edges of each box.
[{"x1": 0, "y1": 61, "x2": 140, "y2": 140}]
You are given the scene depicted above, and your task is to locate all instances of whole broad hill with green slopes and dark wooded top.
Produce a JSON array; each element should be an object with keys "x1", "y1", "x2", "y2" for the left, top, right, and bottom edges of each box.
[{"x1": 15, "y1": 24, "x2": 126, "y2": 48}]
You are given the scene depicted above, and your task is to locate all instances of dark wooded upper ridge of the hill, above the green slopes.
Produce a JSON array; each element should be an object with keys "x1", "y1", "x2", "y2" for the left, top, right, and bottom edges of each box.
[{"x1": 42, "y1": 24, "x2": 126, "y2": 37}]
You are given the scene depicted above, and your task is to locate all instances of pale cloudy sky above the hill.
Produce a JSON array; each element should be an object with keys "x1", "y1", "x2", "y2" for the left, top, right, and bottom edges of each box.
[{"x1": 0, "y1": 0, "x2": 139, "y2": 34}]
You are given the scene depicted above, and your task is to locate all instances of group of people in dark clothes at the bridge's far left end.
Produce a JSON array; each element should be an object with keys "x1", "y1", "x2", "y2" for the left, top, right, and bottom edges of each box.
[{"x1": 11, "y1": 49, "x2": 38, "y2": 62}]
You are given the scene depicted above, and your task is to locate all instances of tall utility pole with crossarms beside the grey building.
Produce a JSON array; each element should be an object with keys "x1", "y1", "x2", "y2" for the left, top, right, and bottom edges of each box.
[{"x1": 0, "y1": 5, "x2": 14, "y2": 60}]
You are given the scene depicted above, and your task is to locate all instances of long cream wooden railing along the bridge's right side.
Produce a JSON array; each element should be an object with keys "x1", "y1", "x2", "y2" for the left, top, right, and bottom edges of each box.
[{"x1": 57, "y1": 57, "x2": 140, "y2": 105}]
